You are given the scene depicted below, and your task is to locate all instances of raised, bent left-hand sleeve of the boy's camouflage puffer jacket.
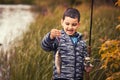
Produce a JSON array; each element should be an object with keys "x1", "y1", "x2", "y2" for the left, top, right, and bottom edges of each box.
[{"x1": 41, "y1": 32, "x2": 55, "y2": 51}]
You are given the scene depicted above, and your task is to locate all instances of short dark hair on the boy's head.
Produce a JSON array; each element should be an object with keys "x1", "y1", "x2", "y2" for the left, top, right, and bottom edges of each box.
[{"x1": 63, "y1": 8, "x2": 80, "y2": 22}]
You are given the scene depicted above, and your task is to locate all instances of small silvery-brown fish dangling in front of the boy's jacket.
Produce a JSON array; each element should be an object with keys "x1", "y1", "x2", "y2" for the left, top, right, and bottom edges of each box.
[{"x1": 55, "y1": 50, "x2": 61, "y2": 75}]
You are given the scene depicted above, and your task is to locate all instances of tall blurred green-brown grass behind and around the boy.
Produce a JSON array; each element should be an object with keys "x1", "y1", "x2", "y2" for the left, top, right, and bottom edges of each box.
[{"x1": 0, "y1": 5, "x2": 120, "y2": 80}]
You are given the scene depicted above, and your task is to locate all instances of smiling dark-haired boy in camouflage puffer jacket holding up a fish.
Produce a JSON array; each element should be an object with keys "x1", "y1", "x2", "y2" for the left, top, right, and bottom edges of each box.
[{"x1": 41, "y1": 8, "x2": 88, "y2": 80}]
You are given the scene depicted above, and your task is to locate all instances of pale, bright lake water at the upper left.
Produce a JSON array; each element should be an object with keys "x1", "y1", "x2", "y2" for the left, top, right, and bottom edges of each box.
[{"x1": 0, "y1": 5, "x2": 35, "y2": 48}]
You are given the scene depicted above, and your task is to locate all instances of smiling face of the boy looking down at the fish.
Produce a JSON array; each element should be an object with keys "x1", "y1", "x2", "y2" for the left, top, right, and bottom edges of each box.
[{"x1": 61, "y1": 16, "x2": 80, "y2": 35}]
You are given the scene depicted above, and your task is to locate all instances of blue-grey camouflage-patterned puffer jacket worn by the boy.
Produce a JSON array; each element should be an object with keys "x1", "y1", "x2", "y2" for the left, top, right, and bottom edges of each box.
[{"x1": 41, "y1": 30, "x2": 88, "y2": 80}]
